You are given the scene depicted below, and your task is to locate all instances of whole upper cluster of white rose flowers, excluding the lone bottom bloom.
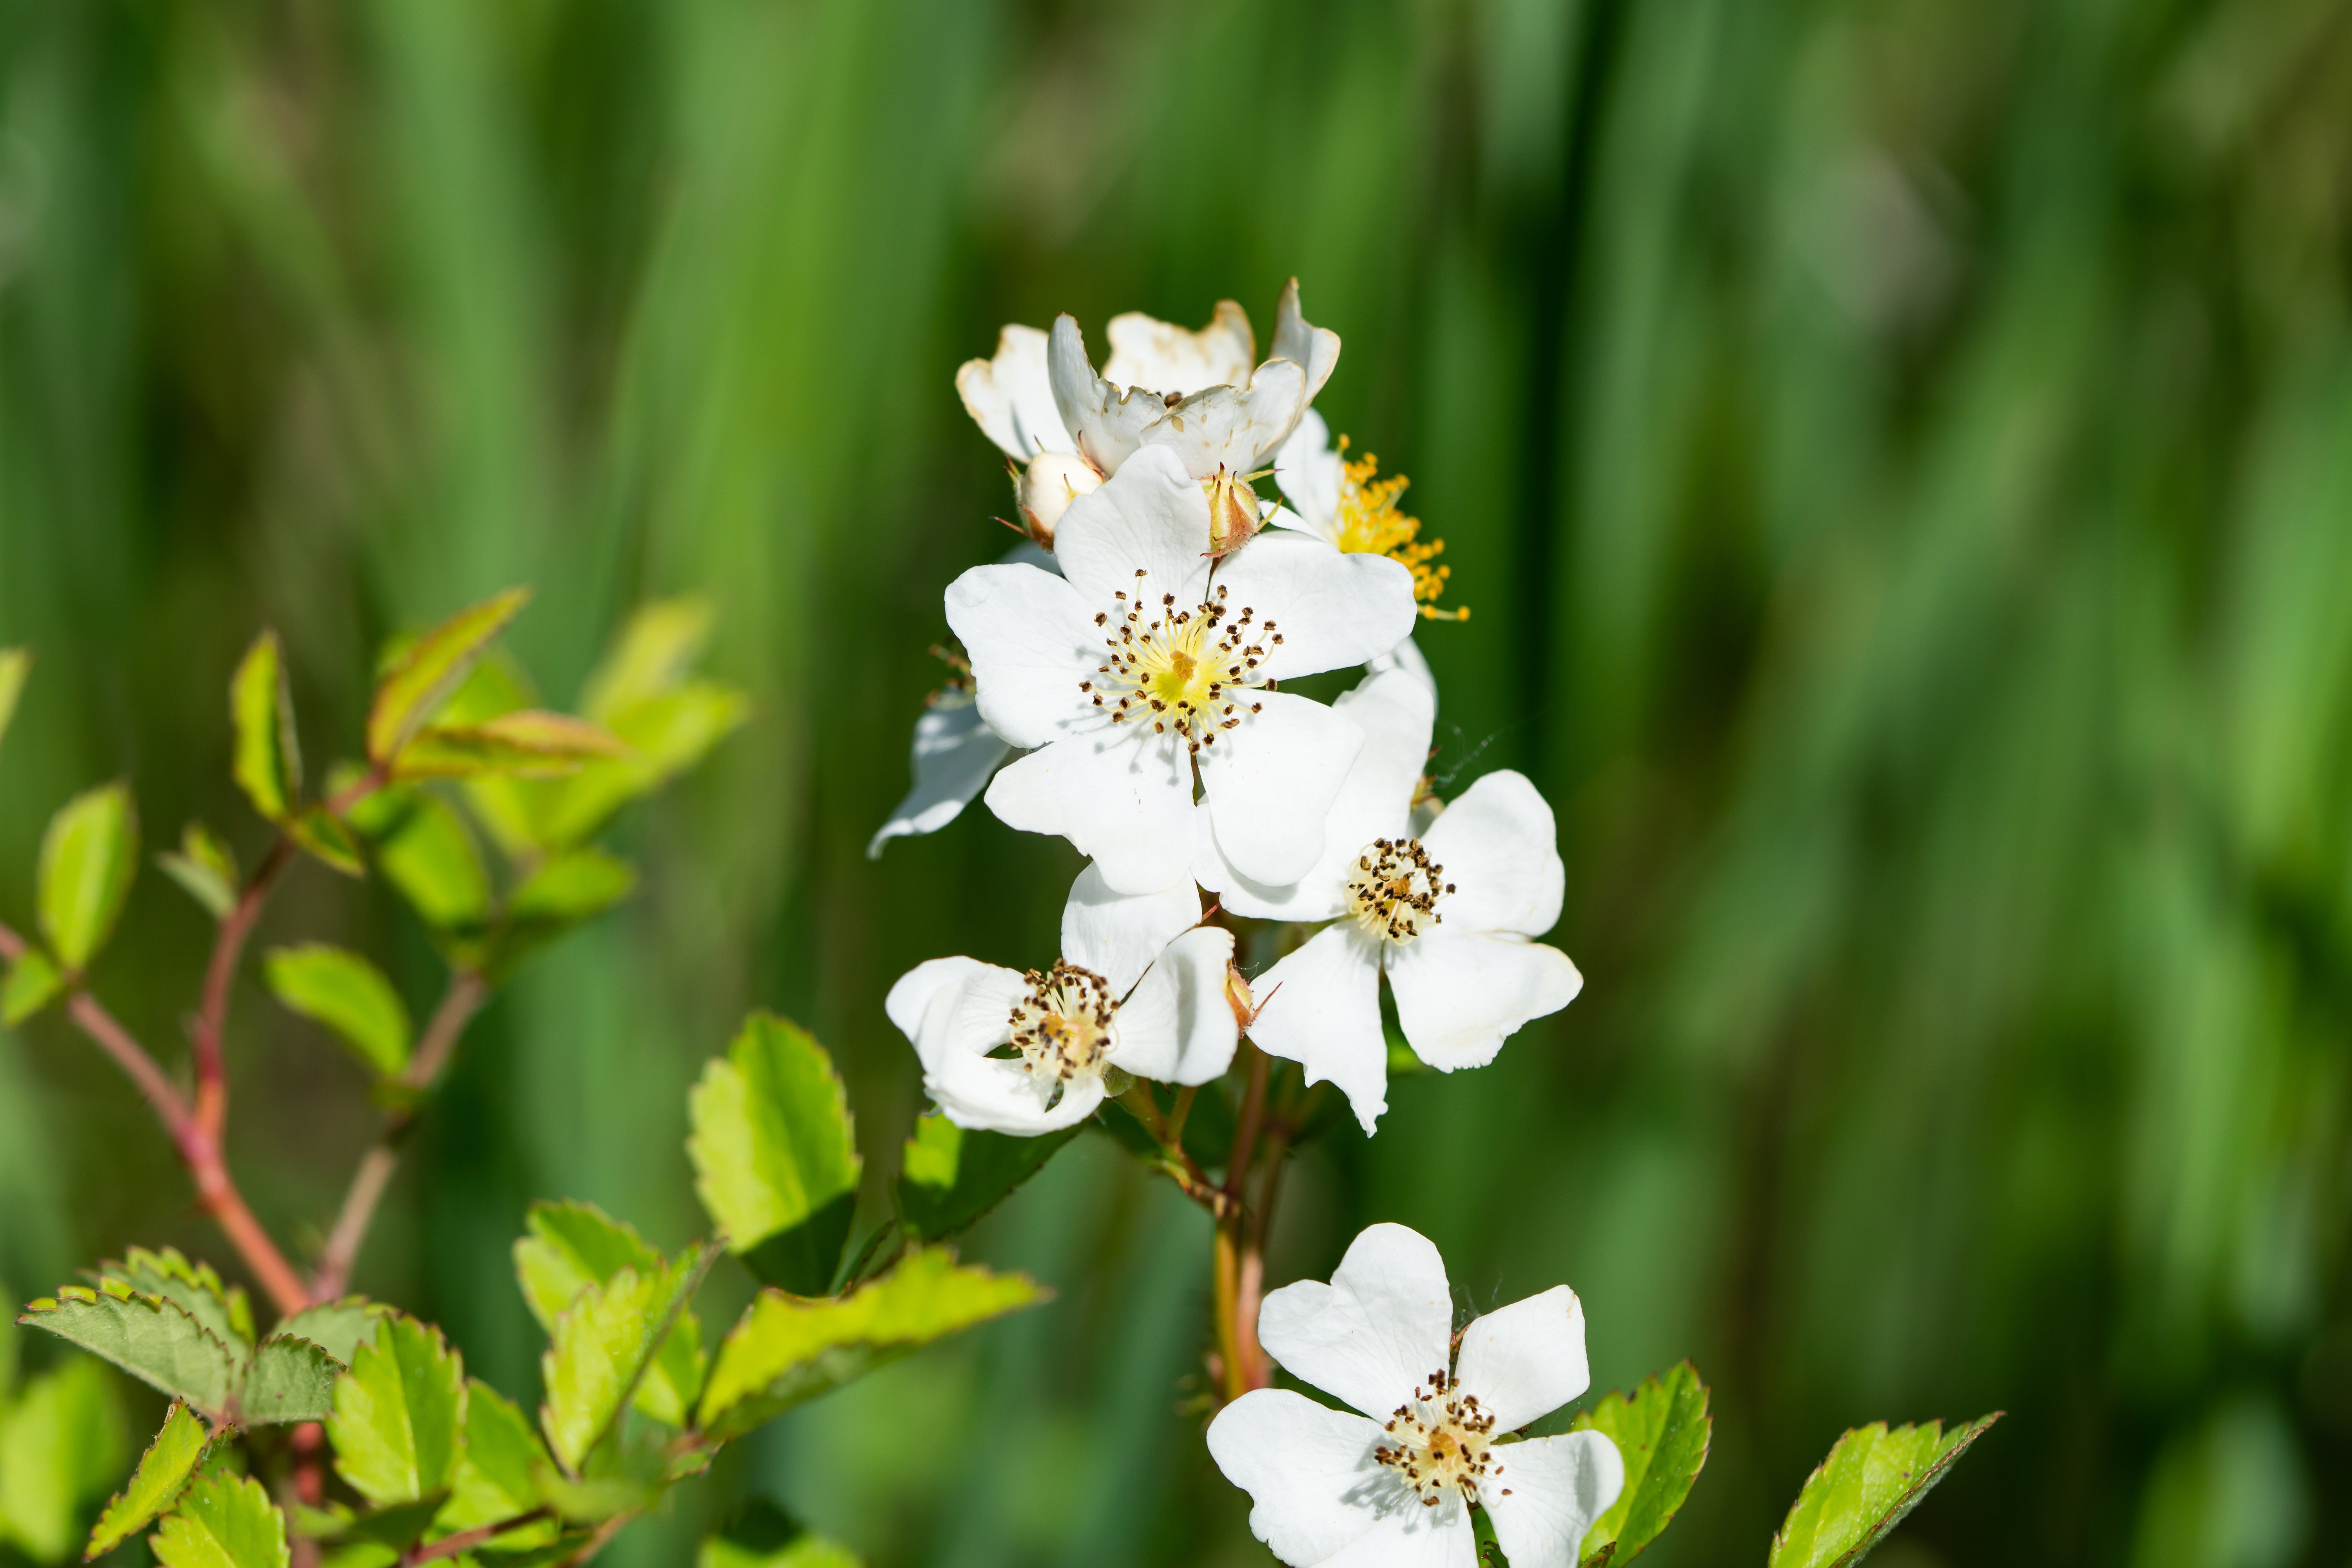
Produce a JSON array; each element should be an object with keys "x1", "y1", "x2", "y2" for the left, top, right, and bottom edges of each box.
[{"x1": 877, "y1": 282, "x2": 1581, "y2": 1136}]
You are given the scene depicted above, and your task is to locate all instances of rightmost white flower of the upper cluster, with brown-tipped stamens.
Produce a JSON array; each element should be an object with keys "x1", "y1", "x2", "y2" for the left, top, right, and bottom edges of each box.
[{"x1": 1192, "y1": 668, "x2": 1583, "y2": 1133}]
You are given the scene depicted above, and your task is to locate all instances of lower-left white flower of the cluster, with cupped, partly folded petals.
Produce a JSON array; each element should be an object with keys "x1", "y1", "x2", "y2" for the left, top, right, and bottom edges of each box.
[{"x1": 884, "y1": 865, "x2": 1240, "y2": 1138}]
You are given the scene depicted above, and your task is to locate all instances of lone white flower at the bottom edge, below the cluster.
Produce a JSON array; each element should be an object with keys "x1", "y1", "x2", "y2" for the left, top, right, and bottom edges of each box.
[{"x1": 1209, "y1": 1225, "x2": 1625, "y2": 1568}]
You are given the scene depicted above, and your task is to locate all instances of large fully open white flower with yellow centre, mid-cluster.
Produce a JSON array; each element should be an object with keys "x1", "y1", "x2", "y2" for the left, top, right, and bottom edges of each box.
[{"x1": 948, "y1": 446, "x2": 1414, "y2": 893}]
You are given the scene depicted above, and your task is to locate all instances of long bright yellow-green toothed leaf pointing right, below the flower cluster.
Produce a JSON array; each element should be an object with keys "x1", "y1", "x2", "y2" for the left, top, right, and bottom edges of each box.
[{"x1": 701, "y1": 1248, "x2": 1049, "y2": 1439}]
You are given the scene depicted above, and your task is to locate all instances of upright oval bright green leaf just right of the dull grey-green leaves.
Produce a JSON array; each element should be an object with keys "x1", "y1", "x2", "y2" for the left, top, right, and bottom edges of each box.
[{"x1": 327, "y1": 1314, "x2": 466, "y2": 1507}]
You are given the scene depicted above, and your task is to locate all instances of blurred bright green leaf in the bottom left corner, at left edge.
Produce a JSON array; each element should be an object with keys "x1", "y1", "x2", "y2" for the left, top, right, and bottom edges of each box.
[{"x1": 0, "y1": 1356, "x2": 125, "y2": 1563}]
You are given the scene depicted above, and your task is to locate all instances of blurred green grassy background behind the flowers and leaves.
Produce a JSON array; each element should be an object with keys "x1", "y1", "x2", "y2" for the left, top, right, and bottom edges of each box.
[{"x1": 0, "y1": 0, "x2": 2352, "y2": 1568}]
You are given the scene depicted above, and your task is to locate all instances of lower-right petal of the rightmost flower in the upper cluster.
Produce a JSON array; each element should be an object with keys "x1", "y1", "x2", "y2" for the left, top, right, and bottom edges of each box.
[{"x1": 1374, "y1": 931, "x2": 1585, "y2": 1072}]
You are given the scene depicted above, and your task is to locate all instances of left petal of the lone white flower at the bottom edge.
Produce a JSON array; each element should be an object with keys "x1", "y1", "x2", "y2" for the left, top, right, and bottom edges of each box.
[{"x1": 1209, "y1": 1389, "x2": 1383, "y2": 1568}]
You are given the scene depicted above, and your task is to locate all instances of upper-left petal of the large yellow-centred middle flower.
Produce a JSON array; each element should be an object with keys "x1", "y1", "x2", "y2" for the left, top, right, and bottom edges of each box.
[{"x1": 948, "y1": 566, "x2": 1103, "y2": 748}]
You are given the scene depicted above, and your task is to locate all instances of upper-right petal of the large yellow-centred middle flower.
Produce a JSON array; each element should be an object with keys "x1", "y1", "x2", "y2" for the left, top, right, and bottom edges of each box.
[{"x1": 1216, "y1": 529, "x2": 1418, "y2": 679}]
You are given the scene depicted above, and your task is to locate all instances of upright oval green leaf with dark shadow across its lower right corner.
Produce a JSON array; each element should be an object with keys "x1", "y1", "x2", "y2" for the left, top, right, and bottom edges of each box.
[{"x1": 687, "y1": 1013, "x2": 858, "y2": 1295}]
